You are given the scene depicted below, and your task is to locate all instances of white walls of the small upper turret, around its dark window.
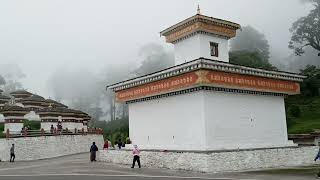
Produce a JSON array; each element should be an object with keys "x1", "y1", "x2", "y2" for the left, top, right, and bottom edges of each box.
[{"x1": 174, "y1": 34, "x2": 229, "y2": 65}]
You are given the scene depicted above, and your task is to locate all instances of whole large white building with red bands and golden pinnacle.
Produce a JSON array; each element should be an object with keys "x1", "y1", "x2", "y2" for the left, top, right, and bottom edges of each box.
[{"x1": 107, "y1": 10, "x2": 304, "y2": 151}]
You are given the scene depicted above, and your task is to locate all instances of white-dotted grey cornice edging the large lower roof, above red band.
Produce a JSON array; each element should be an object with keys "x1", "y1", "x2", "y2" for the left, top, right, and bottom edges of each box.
[{"x1": 106, "y1": 58, "x2": 306, "y2": 91}]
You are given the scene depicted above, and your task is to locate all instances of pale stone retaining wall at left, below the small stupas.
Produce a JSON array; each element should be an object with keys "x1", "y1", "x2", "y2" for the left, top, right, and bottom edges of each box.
[{"x1": 0, "y1": 135, "x2": 104, "y2": 161}]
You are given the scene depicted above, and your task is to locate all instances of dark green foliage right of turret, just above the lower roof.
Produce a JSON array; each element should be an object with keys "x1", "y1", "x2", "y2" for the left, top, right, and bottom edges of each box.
[{"x1": 229, "y1": 51, "x2": 277, "y2": 70}]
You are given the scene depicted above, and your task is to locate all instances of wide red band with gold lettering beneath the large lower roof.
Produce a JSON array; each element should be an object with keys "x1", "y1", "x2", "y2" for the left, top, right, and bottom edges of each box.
[{"x1": 116, "y1": 70, "x2": 300, "y2": 102}]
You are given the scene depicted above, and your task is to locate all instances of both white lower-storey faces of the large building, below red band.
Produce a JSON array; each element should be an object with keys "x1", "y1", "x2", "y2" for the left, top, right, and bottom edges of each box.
[{"x1": 129, "y1": 91, "x2": 294, "y2": 150}]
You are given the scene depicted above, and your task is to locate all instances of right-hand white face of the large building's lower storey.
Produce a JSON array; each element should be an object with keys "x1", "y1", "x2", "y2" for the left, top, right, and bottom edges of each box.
[{"x1": 204, "y1": 91, "x2": 293, "y2": 150}]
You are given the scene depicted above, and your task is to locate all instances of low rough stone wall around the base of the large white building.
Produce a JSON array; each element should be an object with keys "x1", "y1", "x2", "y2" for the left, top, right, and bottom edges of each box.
[{"x1": 99, "y1": 147, "x2": 318, "y2": 173}]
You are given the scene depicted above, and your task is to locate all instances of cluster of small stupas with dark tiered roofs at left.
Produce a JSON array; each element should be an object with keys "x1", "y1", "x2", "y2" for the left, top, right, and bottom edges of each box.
[{"x1": 0, "y1": 90, "x2": 91, "y2": 132}]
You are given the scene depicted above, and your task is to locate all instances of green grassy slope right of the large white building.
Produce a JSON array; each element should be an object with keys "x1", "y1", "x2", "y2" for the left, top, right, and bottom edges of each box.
[{"x1": 286, "y1": 97, "x2": 320, "y2": 134}]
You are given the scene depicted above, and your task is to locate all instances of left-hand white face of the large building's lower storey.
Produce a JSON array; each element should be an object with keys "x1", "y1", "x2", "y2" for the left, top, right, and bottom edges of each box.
[{"x1": 129, "y1": 92, "x2": 206, "y2": 150}]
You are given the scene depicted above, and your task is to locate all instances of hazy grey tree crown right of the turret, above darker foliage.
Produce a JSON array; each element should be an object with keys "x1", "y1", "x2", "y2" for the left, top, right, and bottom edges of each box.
[{"x1": 230, "y1": 26, "x2": 270, "y2": 62}]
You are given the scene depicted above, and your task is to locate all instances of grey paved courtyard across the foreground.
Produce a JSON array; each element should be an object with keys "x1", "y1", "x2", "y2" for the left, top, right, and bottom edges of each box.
[{"x1": 0, "y1": 154, "x2": 317, "y2": 180}]
